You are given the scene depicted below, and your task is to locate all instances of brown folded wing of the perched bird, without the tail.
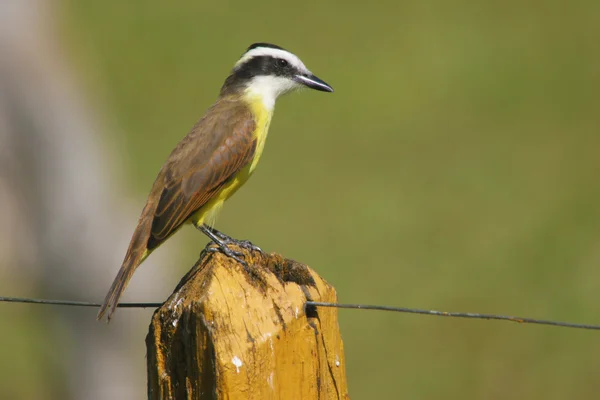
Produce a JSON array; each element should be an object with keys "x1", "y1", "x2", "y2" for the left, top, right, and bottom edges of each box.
[{"x1": 147, "y1": 100, "x2": 256, "y2": 250}]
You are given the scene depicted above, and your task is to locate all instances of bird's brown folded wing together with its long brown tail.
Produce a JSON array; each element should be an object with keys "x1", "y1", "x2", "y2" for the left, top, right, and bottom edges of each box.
[{"x1": 98, "y1": 98, "x2": 256, "y2": 319}]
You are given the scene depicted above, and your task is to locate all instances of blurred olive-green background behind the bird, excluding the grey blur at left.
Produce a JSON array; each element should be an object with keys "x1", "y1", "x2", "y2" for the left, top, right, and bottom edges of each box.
[{"x1": 6, "y1": 0, "x2": 600, "y2": 399}]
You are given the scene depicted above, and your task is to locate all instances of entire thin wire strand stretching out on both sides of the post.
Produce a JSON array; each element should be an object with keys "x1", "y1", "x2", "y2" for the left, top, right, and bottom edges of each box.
[{"x1": 0, "y1": 296, "x2": 600, "y2": 330}]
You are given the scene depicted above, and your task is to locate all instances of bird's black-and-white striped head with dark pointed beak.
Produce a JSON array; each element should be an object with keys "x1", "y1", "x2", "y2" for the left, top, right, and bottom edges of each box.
[{"x1": 222, "y1": 43, "x2": 333, "y2": 108}]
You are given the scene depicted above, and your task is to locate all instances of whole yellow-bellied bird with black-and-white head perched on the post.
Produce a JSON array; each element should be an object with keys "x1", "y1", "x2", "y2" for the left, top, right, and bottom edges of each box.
[{"x1": 98, "y1": 43, "x2": 333, "y2": 320}]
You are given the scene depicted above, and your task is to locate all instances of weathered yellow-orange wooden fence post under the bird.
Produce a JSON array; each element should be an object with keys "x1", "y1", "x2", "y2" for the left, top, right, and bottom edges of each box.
[{"x1": 146, "y1": 244, "x2": 348, "y2": 400}]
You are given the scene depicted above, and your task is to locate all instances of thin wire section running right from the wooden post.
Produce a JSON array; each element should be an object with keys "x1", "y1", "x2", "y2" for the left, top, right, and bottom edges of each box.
[{"x1": 306, "y1": 301, "x2": 600, "y2": 330}]
